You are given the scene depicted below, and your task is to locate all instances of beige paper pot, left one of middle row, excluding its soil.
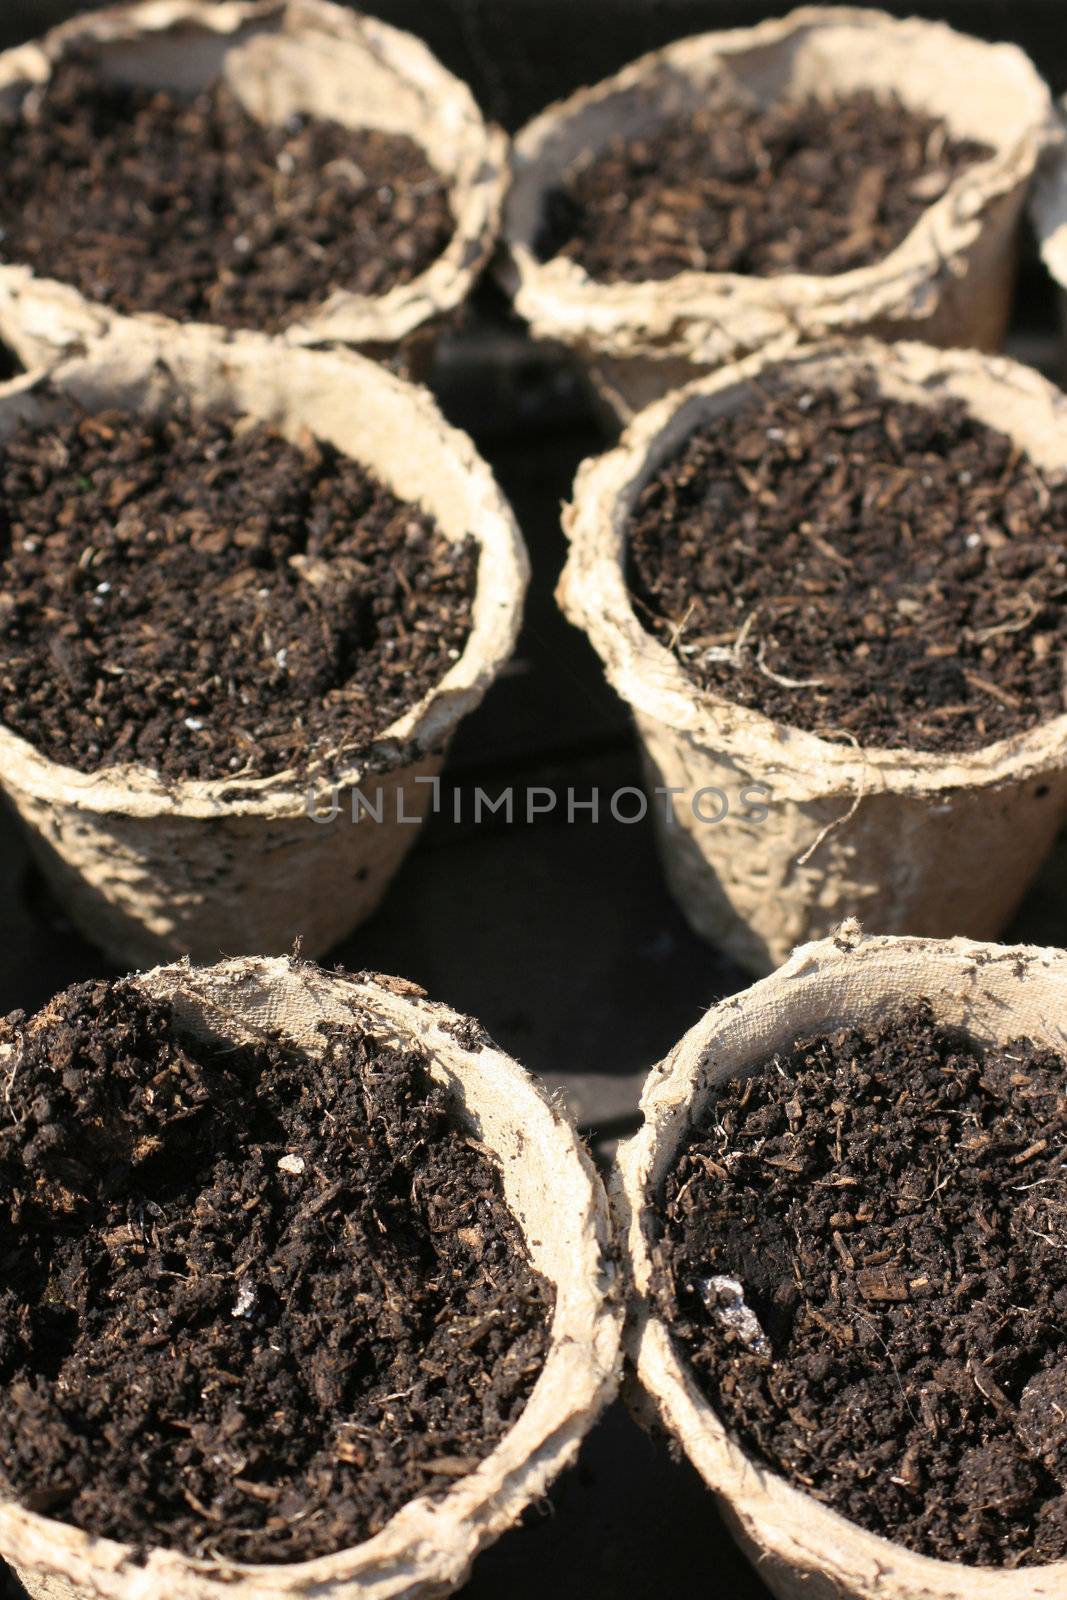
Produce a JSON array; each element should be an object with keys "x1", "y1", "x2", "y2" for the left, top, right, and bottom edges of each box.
[{"x1": 0, "y1": 328, "x2": 528, "y2": 966}]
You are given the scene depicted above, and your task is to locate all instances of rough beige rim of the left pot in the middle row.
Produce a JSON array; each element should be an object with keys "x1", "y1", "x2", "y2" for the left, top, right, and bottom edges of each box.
[{"x1": 0, "y1": 325, "x2": 530, "y2": 818}]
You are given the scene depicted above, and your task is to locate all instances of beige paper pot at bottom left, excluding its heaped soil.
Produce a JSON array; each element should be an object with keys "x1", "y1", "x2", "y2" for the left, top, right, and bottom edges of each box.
[{"x1": 0, "y1": 958, "x2": 621, "y2": 1600}]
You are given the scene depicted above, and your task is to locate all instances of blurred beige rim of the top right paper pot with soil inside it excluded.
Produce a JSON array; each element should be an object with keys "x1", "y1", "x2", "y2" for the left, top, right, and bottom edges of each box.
[{"x1": 499, "y1": 5, "x2": 1057, "y2": 360}]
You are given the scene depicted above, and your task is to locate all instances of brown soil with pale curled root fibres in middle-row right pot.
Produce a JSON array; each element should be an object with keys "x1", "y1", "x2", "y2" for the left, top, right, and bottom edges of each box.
[{"x1": 629, "y1": 373, "x2": 1067, "y2": 752}]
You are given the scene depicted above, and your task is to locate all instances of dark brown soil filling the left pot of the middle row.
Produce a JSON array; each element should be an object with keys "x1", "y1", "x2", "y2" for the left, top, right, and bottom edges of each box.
[{"x1": 0, "y1": 413, "x2": 477, "y2": 779}]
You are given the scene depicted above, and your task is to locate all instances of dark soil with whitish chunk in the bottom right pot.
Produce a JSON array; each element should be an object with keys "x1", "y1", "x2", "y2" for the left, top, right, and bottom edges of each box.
[{"x1": 656, "y1": 1003, "x2": 1067, "y2": 1566}]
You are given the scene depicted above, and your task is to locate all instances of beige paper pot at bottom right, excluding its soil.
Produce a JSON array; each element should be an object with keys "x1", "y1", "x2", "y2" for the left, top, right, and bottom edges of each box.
[{"x1": 613, "y1": 925, "x2": 1067, "y2": 1600}]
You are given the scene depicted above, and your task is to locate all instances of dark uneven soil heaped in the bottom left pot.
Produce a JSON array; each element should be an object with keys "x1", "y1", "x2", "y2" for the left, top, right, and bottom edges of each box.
[{"x1": 0, "y1": 982, "x2": 553, "y2": 1562}]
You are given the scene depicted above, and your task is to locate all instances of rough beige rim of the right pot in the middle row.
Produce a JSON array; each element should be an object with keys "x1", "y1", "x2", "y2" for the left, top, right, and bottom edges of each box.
[{"x1": 557, "y1": 339, "x2": 1067, "y2": 800}]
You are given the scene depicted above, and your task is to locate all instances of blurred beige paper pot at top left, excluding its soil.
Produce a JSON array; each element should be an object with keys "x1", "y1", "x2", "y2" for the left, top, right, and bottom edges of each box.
[{"x1": 0, "y1": 0, "x2": 507, "y2": 376}]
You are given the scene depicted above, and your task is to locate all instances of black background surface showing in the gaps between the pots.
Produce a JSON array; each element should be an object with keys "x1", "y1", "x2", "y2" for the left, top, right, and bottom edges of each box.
[{"x1": 0, "y1": 0, "x2": 1067, "y2": 1600}]
